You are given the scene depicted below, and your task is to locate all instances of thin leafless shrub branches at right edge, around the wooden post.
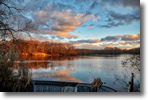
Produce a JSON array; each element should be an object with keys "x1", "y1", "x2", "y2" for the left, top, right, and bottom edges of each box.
[{"x1": 115, "y1": 55, "x2": 140, "y2": 92}]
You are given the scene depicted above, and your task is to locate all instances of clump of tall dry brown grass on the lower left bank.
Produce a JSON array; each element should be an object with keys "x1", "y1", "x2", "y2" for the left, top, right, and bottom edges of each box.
[{"x1": 0, "y1": 45, "x2": 32, "y2": 92}]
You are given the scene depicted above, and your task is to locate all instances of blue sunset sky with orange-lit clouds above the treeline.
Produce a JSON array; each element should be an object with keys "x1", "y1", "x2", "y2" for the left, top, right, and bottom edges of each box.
[{"x1": 15, "y1": 0, "x2": 140, "y2": 49}]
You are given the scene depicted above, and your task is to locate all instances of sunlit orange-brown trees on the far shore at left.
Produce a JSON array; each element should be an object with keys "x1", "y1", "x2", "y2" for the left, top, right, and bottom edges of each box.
[{"x1": 0, "y1": 40, "x2": 78, "y2": 56}]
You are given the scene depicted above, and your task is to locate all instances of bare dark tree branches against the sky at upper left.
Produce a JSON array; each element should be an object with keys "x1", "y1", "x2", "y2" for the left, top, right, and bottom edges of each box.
[{"x1": 0, "y1": 0, "x2": 37, "y2": 40}]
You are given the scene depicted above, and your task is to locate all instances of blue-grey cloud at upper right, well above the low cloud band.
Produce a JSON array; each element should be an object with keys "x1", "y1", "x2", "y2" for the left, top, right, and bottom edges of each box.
[{"x1": 98, "y1": 9, "x2": 140, "y2": 28}]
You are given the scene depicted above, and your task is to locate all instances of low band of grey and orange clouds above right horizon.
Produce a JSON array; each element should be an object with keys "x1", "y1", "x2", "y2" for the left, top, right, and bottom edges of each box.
[{"x1": 72, "y1": 33, "x2": 140, "y2": 49}]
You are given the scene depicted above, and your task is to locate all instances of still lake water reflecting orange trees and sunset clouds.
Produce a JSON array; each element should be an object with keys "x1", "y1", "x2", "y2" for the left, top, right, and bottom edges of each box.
[{"x1": 15, "y1": 54, "x2": 140, "y2": 91}]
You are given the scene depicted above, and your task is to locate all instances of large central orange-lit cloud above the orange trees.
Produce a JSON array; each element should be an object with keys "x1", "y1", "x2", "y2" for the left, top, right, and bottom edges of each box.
[{"x1": 33, "y1": 10, "x2": 98, "y2": 38}]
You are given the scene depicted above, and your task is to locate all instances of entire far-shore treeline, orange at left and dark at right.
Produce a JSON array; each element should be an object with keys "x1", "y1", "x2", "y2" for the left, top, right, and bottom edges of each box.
[{"x1": 0, "y1": 40, "x2": 140, "y2": 56}]
